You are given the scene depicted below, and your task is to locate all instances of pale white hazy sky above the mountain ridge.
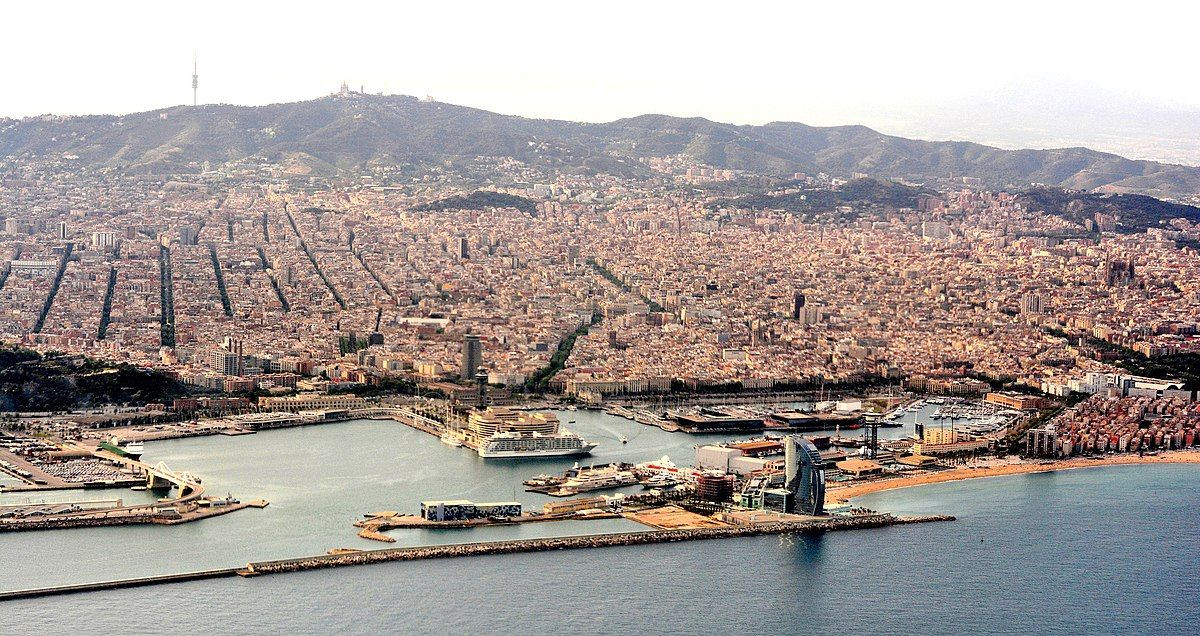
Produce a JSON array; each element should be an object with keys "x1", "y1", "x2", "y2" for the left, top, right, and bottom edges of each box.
[{"x1": 0, "y1": 0, "x2": 1200, "y2": 127}]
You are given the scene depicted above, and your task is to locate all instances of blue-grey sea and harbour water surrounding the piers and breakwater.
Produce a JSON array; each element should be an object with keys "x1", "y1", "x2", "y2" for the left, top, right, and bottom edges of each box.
[{"x1": 0, "y1": 412, "x2": 1200, "y2": 634}]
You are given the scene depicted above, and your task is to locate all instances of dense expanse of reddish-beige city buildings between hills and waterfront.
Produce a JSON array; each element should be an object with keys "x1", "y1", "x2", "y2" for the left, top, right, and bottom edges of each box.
[{"x1": 0, "y1": 97, "x2": 1200, "y2": 395}]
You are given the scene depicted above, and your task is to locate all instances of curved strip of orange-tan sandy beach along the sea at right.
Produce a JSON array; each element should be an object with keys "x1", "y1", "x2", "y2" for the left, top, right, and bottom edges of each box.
[{"x1": 826, "y1": 450, "x2": 1200, "y2": 503}]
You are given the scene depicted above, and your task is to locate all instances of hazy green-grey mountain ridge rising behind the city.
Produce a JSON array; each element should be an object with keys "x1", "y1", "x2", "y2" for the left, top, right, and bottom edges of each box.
[{"x1": 0, "y1": 94, "x2": 1200, "y2": 198}]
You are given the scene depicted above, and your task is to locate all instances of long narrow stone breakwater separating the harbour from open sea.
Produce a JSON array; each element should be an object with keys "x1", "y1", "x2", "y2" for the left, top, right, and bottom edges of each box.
[{"x1": 0, "y1": 514, "x2": 954, "y2": 601}]
